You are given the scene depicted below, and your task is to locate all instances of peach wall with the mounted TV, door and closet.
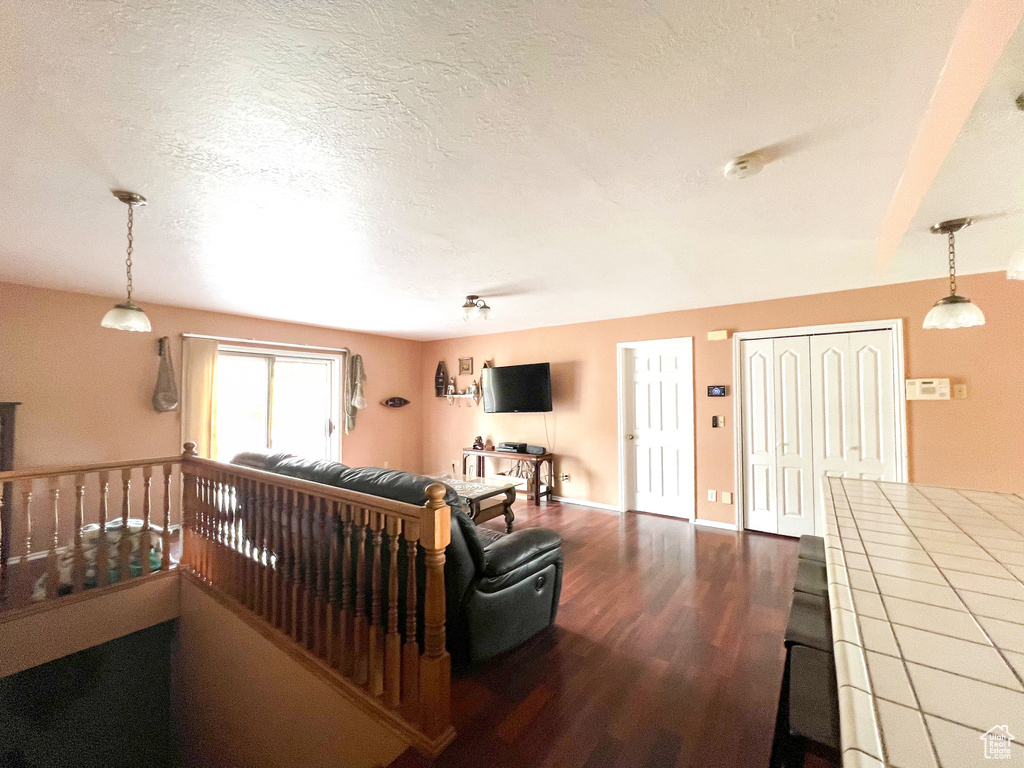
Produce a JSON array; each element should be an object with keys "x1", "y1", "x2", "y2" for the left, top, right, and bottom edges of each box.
[{"x1": 420, "y1": 273, "x2": 1024, "y2": 522}]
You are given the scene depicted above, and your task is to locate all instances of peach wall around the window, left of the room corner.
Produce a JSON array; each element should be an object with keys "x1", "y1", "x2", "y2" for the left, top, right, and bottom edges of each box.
[{"x1": 0, "y1": 283, "x2": 422, "y2": 470}]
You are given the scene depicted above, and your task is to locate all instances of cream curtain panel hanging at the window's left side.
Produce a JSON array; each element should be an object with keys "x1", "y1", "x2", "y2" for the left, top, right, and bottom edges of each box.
[{"x1": 181, "y1": 338, "x2": 219, "y2": 459}]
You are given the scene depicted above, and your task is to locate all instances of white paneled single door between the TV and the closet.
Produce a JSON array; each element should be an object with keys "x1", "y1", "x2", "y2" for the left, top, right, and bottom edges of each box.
[{"x1": 622, "y1": 339, "x2": 696, "y2": 518}]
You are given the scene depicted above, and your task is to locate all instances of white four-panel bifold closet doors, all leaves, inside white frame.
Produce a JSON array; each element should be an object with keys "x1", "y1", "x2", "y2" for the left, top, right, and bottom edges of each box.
[{"x1": 740, "y1": 331, "x2": 898, "y2": 536}]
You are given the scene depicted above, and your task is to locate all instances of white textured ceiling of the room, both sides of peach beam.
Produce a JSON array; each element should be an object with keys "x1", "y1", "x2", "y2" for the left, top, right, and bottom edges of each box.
[{"x1": 0, "y1": 0, "x2": 1007, "y2": 338}]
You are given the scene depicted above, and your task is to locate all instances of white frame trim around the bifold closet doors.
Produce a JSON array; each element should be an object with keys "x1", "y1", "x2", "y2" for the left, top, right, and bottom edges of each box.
[{"x1": 732, "y1": 318, "x2": 909, "y2": 530}]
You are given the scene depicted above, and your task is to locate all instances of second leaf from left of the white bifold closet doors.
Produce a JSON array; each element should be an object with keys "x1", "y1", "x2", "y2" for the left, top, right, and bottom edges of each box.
[{"x1": 773, "y1": 336, "x2": 815, "y2": 536}]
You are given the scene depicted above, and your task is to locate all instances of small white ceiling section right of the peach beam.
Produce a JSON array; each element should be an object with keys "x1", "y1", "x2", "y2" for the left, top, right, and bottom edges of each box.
[{"x1": 887, "y1": 18, "x2": 1024, "y2": 294}]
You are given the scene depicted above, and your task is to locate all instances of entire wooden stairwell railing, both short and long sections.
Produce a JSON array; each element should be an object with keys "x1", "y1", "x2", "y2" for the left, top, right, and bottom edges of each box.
[{"x1": 0, "y1": 443, "x2": 455, "y2": 755}]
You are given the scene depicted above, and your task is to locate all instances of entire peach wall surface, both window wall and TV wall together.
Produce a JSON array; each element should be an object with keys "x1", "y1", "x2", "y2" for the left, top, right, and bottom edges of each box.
[{"x1": 0, "y1": 273, "x2": 1024, "y2": 521}]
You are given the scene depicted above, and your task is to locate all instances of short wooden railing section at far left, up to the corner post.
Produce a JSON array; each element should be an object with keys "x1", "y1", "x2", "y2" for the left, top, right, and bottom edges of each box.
[{"x1": 0, "y1": 456, "x2": 181, "y2": 609}]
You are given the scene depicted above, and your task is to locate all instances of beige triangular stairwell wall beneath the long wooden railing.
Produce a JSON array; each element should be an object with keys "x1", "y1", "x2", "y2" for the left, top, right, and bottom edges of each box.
[{"x1": 174, "y1": 577, "x2": 409, "y2": 768}]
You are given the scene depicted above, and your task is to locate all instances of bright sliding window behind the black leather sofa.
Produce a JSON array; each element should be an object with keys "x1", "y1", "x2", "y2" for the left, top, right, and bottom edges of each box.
[{"x1": 216, "y1": 347, "x2": 342, "y2": 462}]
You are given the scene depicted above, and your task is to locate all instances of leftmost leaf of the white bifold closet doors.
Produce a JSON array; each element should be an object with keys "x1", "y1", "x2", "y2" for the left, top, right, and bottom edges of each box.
[{"x1": 740, "y1": 339, "x2": 778, "y2": 534}]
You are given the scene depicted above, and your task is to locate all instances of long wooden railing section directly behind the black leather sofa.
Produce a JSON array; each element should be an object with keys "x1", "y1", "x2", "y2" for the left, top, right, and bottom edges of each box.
[{"x1": 181, "y1": 443, "x2": 455, "y2": 754}]
